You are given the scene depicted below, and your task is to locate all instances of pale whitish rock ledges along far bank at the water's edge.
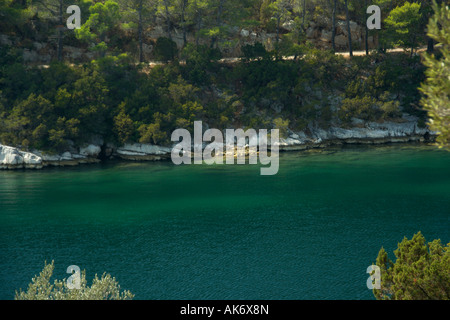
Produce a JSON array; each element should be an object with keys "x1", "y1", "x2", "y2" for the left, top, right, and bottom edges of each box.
[{"x1": 0, "y1": 115, "x2": 436, "y2": 170}]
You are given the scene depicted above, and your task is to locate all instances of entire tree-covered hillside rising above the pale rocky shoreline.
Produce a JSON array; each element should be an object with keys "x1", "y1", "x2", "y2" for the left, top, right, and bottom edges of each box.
[{"x1": 0, "y1": 0, "x2": 442, "y2": 152}]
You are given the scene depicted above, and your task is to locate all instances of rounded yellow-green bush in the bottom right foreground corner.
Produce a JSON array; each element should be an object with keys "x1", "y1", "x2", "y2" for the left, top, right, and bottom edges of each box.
[{"x1": 373, "y1": 232, "x2": 450, "y2": 300}]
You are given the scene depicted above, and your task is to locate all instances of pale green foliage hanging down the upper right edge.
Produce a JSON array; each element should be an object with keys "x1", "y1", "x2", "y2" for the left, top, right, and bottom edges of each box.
[{"x1": 421, "y1": 0, "x2": 450, "y2": 148}]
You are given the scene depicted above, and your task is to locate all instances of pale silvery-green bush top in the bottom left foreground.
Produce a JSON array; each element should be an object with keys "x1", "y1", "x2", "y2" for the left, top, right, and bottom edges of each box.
[{"x1": 14, "y1": 261, "x2": 134, "y2": 300}]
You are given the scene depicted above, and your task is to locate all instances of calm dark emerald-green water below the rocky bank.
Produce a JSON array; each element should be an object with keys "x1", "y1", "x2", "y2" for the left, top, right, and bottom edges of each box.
[{"x1": 0, "y1": 146, "x2": 450, "y2": 299}]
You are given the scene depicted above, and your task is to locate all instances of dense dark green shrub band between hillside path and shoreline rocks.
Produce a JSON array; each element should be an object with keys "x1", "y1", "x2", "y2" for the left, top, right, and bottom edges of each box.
[{"x1": 0, "y1": 41, "x2": 423, "y2": 151}]
